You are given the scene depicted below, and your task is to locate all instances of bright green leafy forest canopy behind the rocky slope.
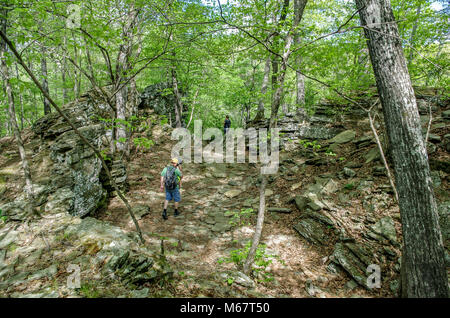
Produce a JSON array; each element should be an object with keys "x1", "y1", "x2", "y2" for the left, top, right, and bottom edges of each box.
[{"x1": 0, "y1": 0, "x2": 449, "y2": 136}]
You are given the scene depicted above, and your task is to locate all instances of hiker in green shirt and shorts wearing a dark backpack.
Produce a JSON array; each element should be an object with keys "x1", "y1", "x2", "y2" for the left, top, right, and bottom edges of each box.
[{"x1": 161, "y1": 158, "x2": 183, "y2": 220}]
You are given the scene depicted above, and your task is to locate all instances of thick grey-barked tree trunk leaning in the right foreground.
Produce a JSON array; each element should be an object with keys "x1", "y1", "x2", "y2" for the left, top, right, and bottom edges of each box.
[{"x1": 355, "y1": 0, "x2": 448, "y2": 298}]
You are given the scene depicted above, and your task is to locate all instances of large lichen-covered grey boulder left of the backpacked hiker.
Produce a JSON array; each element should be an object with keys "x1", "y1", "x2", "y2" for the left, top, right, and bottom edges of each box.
[{"x1": 33, "y1": 93, "x2": 112, "y2": 217}]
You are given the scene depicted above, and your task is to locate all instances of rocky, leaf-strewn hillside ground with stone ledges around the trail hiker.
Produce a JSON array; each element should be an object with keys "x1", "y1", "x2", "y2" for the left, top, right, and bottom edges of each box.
[{"x1": 0, "y1": 89, "x2": 450, "y2": 297}]
